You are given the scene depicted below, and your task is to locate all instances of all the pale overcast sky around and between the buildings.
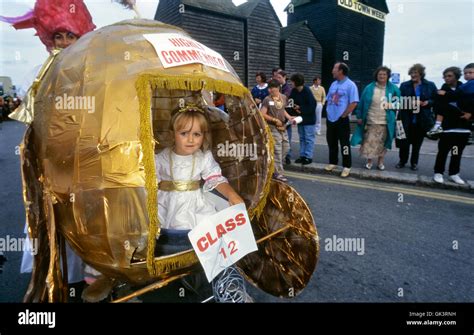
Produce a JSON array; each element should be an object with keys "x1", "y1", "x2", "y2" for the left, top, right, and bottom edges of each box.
[{"x1": 0, "y1": 0, "x2": 474, "y2": 90}]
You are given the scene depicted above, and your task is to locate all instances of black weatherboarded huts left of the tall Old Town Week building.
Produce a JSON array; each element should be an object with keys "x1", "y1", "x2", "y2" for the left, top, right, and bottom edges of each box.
[{"x1": 155, "y1": 0, "x2": 322, "y2": 86}]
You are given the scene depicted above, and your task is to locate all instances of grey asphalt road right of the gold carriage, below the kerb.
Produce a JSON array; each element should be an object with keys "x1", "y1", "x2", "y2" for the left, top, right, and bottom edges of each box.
[{"x1": 249, "y1": 172, "x2": 474, "y2": 304}]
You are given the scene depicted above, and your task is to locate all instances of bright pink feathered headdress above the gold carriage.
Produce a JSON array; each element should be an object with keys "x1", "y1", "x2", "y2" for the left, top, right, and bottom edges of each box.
[{"x1": 0, "y1": 0, "x2": 96, "y2": 50}]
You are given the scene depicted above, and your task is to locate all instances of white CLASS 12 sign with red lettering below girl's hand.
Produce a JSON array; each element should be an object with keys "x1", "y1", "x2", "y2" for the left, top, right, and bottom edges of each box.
[{"x1": 188, "y1": 204, "x2": 257, "y2": 282}]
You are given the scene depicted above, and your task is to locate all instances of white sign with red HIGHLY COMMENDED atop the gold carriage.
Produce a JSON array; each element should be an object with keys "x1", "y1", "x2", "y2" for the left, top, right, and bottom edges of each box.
[{"x1": 143, "y1": 34, "x2": 230, "y2": 72}]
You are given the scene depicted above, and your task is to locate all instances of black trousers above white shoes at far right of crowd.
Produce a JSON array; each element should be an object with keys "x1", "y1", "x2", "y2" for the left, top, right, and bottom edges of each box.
[{"x1": 435, "y1": 133, "x2": 469, "y2": 176}]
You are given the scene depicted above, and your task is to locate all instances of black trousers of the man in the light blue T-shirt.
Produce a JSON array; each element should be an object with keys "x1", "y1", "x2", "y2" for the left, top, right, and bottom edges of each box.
[{"x1": 326, "y1": 117, "x2": 352, "y2": 168}]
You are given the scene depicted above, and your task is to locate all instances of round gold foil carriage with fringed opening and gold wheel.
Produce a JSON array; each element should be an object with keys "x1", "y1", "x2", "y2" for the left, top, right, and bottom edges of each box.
[{"x1": 21, "y1": 20, "x2": 318, "y2": 302}]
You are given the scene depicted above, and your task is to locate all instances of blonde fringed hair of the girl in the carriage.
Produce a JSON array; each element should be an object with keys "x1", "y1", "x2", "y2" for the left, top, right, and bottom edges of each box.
[{"x1": 170, "y1": 107, "x2": 212, "y2": 151}]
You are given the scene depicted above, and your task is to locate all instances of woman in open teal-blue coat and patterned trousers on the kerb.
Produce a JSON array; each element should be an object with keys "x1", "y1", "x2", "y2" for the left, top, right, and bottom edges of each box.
[{"x1": 351, "y1": 66, "x2": 400, "y2": 170}]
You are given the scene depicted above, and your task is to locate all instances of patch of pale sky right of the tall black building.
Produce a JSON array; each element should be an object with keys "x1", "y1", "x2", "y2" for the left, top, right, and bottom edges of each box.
[{"x1": 384, "y1": 0, "x2": 474, "y2": 86}]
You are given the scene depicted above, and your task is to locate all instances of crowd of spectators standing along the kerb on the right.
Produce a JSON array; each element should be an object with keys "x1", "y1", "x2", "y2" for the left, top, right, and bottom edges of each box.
[{"x1": 251, "y1": 62, "x2": 474, "y2": 185}]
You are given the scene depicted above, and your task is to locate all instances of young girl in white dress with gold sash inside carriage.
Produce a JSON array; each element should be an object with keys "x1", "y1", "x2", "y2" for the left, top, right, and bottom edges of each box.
[{"x1": 155, "y1": 107, "x2": 244, "y2": 230}]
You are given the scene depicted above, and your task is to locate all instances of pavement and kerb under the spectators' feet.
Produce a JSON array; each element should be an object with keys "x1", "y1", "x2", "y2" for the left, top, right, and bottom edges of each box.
[{"x1": 284, "y1": 119, "x2": 474, "y2": 193}]
